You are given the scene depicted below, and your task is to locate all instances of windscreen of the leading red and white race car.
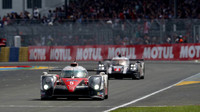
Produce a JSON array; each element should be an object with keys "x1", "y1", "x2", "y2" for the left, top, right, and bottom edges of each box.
[{"x1": 61, "y1": 70, "x2": 88, "y2": 78}]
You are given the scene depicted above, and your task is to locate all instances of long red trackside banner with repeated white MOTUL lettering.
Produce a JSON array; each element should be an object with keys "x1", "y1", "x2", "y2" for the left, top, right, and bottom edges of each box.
[{"x1": 29, "y1": 44, "x2": 200, "y2": 61}]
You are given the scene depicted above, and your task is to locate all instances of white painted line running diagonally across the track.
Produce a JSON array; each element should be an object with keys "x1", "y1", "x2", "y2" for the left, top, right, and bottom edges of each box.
[{"x1": 104, "y1": 73, "x2": 200, "y2": 112}]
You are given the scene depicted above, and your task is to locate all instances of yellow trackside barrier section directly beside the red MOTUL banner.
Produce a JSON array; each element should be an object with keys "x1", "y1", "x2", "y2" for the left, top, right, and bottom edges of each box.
[{"x1": 19, "y1": 47, "x2": 28, "y2": 62}]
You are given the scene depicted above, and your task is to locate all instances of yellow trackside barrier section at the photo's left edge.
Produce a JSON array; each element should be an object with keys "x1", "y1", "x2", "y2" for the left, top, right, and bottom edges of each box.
[{"x1": 0, "y1": 47, "x2": 10, "y2": 62}]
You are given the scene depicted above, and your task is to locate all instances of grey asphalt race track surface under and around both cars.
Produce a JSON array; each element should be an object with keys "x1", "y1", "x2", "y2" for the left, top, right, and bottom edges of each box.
[{"x1": 0, "y1": 62, "x2": 200, "y2": 112}]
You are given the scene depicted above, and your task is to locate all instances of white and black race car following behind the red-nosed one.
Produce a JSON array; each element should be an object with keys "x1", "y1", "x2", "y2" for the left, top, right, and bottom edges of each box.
[{"x1": 97, "y1": 55, "x2": 145, "y2": 79}]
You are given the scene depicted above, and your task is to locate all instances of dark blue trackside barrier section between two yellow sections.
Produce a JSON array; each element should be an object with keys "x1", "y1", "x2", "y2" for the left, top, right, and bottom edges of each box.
[{"x1": 9, "y1": 47, "x2": 19, "y2": 62}]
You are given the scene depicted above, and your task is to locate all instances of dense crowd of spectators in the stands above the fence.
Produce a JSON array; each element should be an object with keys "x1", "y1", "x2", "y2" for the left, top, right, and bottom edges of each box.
[{"x1": 1, "y1": 0, "x2": 200, "y2": 22}]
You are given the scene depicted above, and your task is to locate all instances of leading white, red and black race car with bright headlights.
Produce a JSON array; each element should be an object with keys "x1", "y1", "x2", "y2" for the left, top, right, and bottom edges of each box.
[{"x1": 41, "y1": 62, "x2": 108, "y2": 100}]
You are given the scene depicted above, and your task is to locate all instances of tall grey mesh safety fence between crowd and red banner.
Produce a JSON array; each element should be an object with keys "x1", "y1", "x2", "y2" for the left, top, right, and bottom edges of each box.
[{"x1": 0, "y1": 19, "x2": 200, "y2": 46}]
